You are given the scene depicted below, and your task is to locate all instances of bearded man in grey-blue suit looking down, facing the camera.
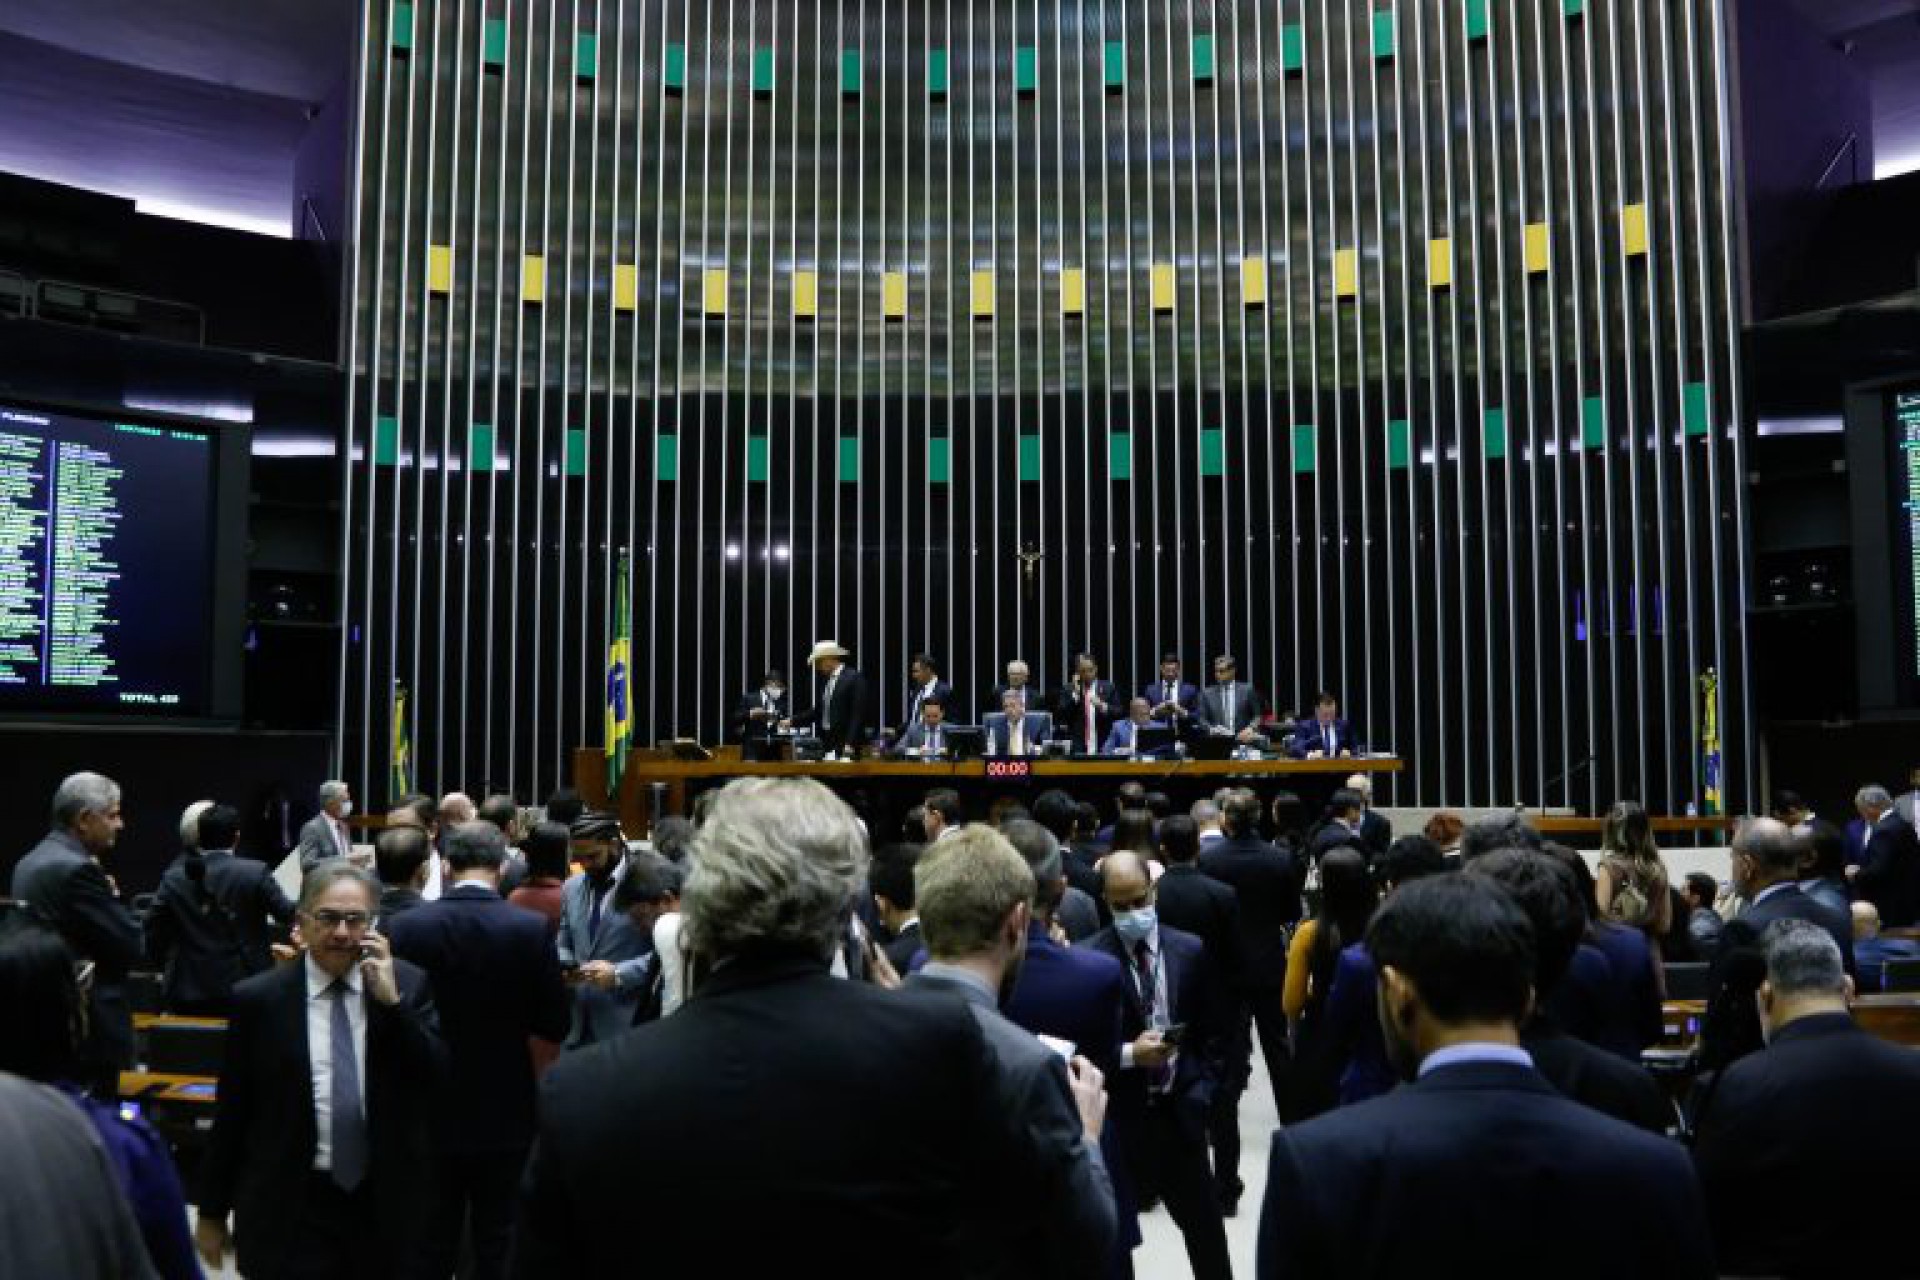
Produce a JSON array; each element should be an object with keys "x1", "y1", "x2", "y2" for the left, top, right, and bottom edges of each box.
[{"x1": 555, "y1": 814, "x2": 653, "y2": 1050}]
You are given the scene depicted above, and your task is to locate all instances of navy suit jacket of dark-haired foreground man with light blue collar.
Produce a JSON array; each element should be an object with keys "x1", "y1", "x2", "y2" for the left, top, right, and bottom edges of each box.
[{"x1": 1258, "y1": 1061, "x2": 1715, "y2": 1280}]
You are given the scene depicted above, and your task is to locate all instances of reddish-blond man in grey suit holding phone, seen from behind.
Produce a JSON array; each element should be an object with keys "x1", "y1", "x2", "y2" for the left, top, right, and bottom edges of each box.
[{"x1": 906, "y1": 825, "x2": 1116, "y2": 1276}]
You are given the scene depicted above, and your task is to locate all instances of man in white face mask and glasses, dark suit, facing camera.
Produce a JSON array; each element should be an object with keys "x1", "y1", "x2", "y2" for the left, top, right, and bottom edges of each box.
[{"x1": 1085, "y1": 852, "x2": 1233, "y2": 1280}]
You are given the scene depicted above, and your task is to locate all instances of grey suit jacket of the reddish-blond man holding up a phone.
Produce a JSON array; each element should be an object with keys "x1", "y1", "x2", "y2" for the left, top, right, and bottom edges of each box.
[{"x1": 906, "y1": 971, "x2": 1117, "y2": 1280}]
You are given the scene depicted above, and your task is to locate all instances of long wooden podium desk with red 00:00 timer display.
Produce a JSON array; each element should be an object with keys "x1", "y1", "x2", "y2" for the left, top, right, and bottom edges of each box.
[{"x1": 574, "y1": 747, "x2": 1404, "y2": 835}]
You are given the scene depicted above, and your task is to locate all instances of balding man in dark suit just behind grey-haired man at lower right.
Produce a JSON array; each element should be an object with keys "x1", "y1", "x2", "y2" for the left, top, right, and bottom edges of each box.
[{"x1": 1701, "y1": 818, "x2": 1853, "y2": 1071}]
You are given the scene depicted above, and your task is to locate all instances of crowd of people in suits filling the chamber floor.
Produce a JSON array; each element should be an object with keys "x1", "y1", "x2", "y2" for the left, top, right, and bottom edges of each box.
[{"x1": 0, "y1": 767, "x2": 1920, "y2": 1280}]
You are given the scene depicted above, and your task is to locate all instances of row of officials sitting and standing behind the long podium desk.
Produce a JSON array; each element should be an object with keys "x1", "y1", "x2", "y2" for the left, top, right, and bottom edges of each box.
[{"x1": 730, "y1": 639, "x2": 1363, "y2": 760}]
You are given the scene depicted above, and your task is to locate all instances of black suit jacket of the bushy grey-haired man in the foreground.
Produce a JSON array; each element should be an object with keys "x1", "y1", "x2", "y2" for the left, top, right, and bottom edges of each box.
[{"x1": 511, "y1": 950, "x2": 1098, "y2": 1280}]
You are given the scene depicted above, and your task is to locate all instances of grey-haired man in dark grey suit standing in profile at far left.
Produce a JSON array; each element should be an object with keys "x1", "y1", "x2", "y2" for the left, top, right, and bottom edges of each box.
[{"x1": 13, "y1": 773, "x2": 140, "y2": 1100}]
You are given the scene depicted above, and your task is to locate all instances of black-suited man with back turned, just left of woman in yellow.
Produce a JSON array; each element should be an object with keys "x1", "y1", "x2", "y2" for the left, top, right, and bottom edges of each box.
[{"x1": 1200, "y1": 787, "x2": 1306, "y2": 1123}]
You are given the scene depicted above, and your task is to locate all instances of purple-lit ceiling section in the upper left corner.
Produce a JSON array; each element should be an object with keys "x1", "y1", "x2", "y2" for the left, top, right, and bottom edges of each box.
[{"x1": 0, "y1": 0, "x2": 359, "y2": 236}]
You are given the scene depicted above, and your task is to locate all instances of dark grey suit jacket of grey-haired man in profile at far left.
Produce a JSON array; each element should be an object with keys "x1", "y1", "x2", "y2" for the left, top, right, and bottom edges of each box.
[{"x1": 13, "y1": 831, "x2": 142, "y2": 1080}]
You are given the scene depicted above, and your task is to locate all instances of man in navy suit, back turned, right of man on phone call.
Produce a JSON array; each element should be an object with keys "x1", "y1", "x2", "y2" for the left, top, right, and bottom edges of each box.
[{"x1": 390, "y1": 821, "x2": 570, "y2": 1276}]
